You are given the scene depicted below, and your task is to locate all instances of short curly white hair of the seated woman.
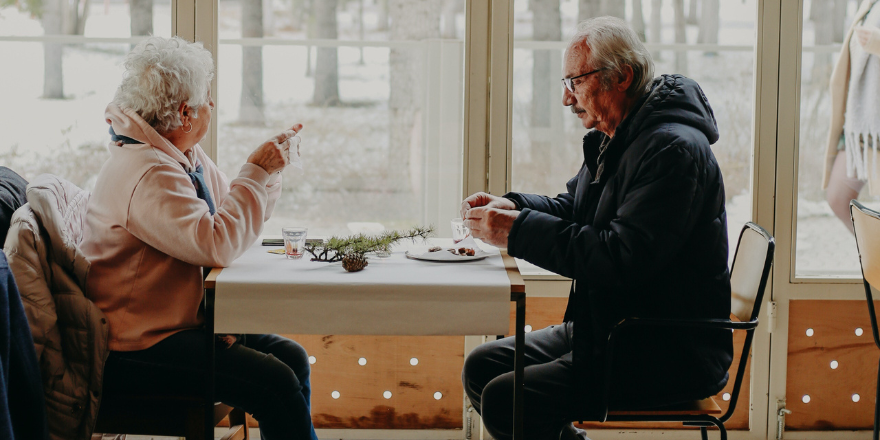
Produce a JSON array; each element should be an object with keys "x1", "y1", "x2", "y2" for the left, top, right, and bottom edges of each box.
[{"x1": 113, "y1": 37, "x2": 214, "y2": 134}]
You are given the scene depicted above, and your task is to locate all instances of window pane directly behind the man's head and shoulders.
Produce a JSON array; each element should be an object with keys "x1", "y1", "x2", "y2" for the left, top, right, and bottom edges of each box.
[{"x1": 512, "y1": 0, "x2": 757, "y2": 259}]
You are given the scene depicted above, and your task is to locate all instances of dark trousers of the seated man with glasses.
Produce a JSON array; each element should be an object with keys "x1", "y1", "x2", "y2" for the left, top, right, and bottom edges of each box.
[{"x1": 461, "y1": 322, "x2": 583, "y2": 440}]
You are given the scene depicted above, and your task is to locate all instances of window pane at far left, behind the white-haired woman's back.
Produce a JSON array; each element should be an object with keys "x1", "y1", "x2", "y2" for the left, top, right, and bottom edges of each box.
[{"x1": 0, "y1": 0, "x2": 171, "y2": 188}]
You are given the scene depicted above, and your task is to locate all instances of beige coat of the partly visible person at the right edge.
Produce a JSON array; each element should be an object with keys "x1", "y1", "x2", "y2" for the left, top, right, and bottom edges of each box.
[{"x1": 822, "y1": 0, "x2": 880, "y2": 195}]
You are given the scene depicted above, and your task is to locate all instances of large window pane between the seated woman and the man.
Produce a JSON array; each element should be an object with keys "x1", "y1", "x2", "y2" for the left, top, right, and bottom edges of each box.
[{"x1": 217, "y1": 0, "x2": 464, "y2": 236}]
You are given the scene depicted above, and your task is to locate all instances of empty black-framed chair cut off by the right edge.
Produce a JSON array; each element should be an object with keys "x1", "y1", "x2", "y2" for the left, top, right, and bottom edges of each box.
[{"x1": 849, "y1": 200, "x2": 880, "y2": 440}]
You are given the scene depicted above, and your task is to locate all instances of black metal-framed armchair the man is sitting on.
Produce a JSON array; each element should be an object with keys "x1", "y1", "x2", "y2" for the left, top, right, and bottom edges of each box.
[{"x1": 580, "y1": 222, "x2": 776, "y2": 440}]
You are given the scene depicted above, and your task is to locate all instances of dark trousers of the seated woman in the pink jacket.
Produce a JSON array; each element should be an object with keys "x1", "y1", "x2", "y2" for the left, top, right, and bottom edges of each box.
[{"x1": 104, "y1": 330, "x2": 318, "y2": 440}]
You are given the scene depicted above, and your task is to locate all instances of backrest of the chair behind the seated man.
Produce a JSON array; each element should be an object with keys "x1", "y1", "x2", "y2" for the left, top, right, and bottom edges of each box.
[{"x1": 730, "y1": 222, "x2": 776, "y2": 322}]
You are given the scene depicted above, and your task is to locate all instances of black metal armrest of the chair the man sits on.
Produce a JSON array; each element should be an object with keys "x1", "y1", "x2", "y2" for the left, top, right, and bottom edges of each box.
[{"x1": 601, "y1": 318, "x2": 758, "y2": 421}]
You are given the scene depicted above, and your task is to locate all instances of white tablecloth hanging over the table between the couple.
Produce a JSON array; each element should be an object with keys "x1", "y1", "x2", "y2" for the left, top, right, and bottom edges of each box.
[{"x1": 214, "y1": 239, "x2": 510, "y2": 335}]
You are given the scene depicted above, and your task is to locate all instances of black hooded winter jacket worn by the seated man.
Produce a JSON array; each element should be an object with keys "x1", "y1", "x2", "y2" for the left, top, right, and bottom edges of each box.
[{"x1": 505, "y1": 75, "x2": 733, "y2": 409}]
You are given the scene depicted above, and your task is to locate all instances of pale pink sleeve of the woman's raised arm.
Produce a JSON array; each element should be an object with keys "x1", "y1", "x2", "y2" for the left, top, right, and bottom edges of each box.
[{"x1": 125, "y1": 163, "x2": 269, "y2": 267}]
